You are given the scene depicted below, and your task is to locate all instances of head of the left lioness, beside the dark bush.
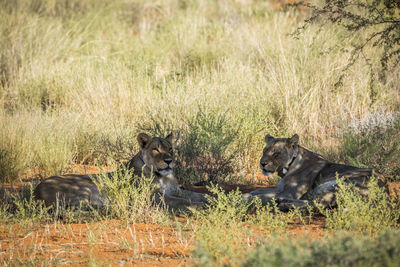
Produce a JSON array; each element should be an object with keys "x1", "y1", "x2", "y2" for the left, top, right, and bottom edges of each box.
[{"x1": 137, "y1": 133, "x2": 174, "y2": 176}]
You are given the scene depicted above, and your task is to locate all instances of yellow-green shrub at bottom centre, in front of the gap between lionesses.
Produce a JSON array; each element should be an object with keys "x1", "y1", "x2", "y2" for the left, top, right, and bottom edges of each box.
[{"x1": 192, "y1": 186, "x2": 251, "y2": 266}]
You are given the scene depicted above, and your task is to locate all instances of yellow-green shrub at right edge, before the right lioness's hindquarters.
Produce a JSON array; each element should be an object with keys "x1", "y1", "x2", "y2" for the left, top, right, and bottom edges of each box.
[{"x1": 320, "y1": 178, "x2": 400, "y2": 232}]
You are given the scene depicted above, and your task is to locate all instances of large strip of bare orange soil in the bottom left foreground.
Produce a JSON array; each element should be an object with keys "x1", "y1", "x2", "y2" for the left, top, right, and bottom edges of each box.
[{"x1": 0, "y1": 220, "x2": 193, "y2": 266}]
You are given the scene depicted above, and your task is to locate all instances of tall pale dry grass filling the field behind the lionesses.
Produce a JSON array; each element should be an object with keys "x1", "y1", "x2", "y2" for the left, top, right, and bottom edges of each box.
[{"x1": 0, "y1": 0, "x2": 400, "y2": 180}]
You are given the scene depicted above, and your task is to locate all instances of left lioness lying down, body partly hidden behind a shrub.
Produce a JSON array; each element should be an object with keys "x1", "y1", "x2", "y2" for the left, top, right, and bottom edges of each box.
[{"x1": 34, "y1": 133, "x2": 206, "y2": 210}]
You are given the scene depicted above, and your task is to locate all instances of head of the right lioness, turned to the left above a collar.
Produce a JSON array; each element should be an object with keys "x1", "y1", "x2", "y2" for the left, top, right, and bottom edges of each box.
[{"x1": 260, "y1": 134, "x2": 299, "y2": 177}]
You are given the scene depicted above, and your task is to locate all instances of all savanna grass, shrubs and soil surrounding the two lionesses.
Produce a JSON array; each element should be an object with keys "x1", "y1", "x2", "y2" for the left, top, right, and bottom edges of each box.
[{"x1": 0, "y1": 0, "x2": 400, "y2": 266}]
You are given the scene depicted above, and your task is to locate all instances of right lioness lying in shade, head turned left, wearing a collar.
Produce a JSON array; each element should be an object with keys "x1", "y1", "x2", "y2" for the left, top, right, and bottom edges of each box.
[{"x1": 245, "y1": 134, "x2": 383, "y2": 210}]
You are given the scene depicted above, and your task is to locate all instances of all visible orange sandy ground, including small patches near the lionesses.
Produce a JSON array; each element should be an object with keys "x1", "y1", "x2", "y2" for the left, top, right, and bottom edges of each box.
[{"x1": 0, "y1": 166, "x2": 400, "y2": 266}]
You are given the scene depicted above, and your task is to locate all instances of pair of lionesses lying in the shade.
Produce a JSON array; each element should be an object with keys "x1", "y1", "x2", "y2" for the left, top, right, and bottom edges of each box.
[{"x1": 34, "y1": 133, "x2": 384, "y2": 213}]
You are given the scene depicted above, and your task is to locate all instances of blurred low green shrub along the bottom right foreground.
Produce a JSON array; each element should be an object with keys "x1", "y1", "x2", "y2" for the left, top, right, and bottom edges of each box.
[{"x1": 243, "y1": 230, "x2": 400, "y2": 267}]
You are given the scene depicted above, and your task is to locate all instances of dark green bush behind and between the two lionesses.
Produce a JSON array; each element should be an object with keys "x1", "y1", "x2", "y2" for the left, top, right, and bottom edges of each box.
[{"x1": 176, "y1": 111, "x2": 238, "y2": 186}]
